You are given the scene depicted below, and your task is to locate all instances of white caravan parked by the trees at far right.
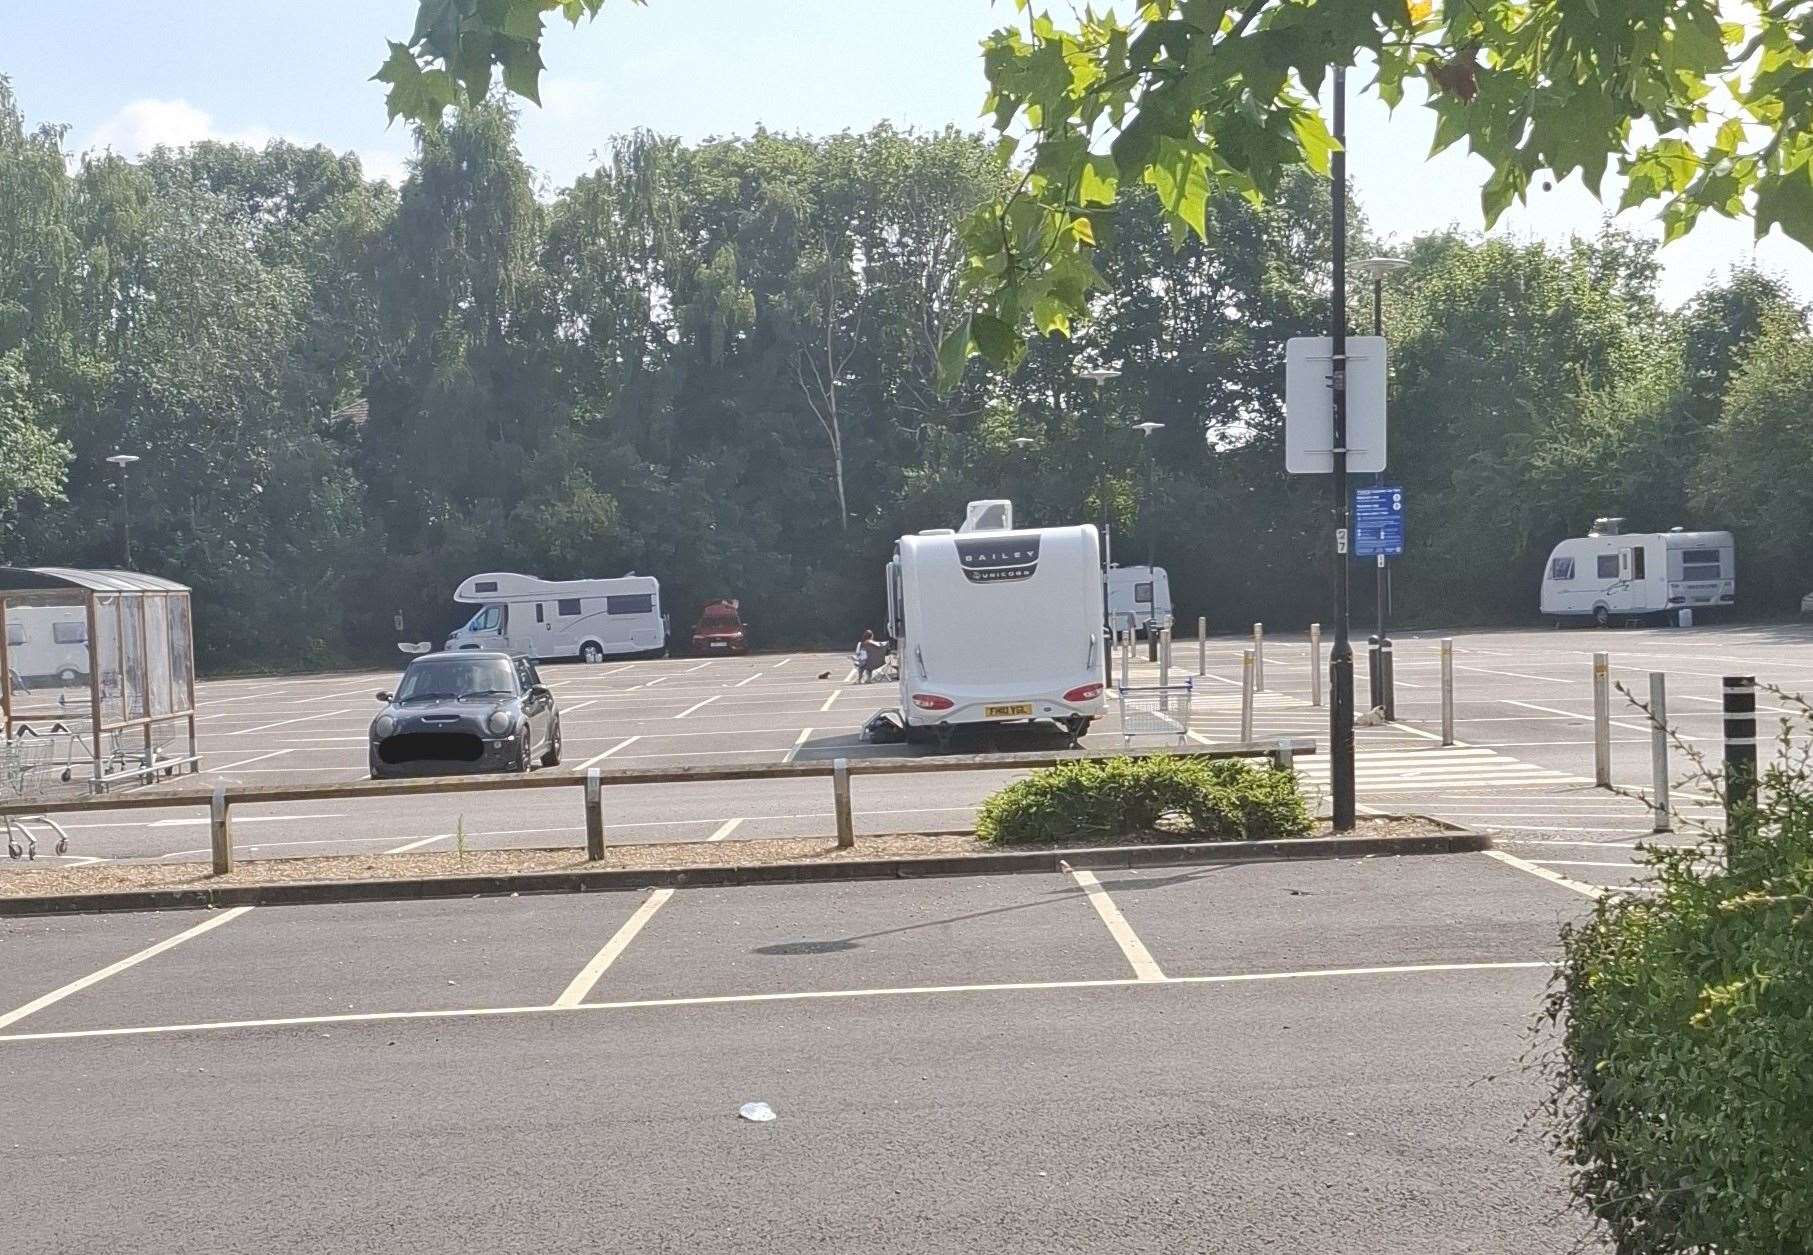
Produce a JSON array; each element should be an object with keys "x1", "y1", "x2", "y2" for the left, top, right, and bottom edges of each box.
[{"x1": 1541, "y1": 519, "x2": 1737, "y2": 628}]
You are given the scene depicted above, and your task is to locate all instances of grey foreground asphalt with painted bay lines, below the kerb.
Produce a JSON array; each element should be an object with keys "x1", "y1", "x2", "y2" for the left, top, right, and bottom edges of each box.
[{"x1": 0, "y1": 854, "x2": 1594, "y2": 1253}]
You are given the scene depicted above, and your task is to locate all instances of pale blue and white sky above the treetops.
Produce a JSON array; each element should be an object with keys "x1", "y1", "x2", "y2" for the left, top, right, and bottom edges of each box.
[{"x1": 0, "y1": 0, "x2": 1813, "y2": 305}]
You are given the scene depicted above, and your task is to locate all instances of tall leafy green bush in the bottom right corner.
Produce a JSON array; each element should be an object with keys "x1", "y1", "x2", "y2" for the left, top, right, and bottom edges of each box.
[{"x1": 1545, "y1": 797, "x2": 1813, "y2": 1255}]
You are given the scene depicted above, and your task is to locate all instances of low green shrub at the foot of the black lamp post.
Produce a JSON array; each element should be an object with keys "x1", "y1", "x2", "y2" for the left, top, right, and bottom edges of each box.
[{"x1": 975, "y1": 756, "x2": 1313, "y2": 845}]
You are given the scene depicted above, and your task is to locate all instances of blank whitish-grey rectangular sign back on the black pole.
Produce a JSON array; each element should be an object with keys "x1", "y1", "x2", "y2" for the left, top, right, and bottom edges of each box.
[{"x1": 1284, "y1": 336, "x2": 1385, "y2": 475}]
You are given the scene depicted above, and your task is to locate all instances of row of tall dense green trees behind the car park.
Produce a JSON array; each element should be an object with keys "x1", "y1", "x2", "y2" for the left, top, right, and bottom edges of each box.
[{"x1": 0, "y1": 80, "x2": 1813, "y2": 667}]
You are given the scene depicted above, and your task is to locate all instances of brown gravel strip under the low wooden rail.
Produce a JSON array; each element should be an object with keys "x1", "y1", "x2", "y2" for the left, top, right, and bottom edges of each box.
[{"x1": 0, "y1": 820, "x2": 1447, "y2": 898}]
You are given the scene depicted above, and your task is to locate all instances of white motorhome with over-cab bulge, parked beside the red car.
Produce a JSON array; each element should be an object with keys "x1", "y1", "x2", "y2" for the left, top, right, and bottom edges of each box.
[{"x1": 446, "y1": 571, "x2": 667, "y2": 662}]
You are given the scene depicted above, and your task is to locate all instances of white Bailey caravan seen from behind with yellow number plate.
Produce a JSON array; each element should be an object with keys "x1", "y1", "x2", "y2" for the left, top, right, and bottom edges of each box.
[{"x1": 888, "y1": 502, "x2": 1104, "y2": 742}]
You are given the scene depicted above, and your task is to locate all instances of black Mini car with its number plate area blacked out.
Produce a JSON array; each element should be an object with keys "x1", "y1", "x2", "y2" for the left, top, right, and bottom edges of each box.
[{"x1": 372, "y1": 649, "x2": 560, "y2": 780}]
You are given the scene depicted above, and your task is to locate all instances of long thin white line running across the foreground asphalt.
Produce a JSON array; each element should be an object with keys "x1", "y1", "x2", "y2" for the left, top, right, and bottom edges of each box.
[{"x1": 0, "y1": 964, "x2": 1554, "y2": 1043}]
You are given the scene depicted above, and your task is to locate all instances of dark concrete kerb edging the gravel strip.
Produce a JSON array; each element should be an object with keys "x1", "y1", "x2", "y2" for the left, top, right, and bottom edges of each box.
[{"x1": 0, "y1": 816, "x2": 1492, "y2": 918}]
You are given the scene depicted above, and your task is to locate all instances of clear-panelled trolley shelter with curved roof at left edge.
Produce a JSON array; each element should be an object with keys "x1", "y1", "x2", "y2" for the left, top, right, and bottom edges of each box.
[{"x1": 0, "y1": 568, "x2": 201, "y2": 794}]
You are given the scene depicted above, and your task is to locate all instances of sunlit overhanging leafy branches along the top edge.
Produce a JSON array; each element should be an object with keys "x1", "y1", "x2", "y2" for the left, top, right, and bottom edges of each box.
[{"x1": 375, "y1": 0, "x2": 1813, "y2": 368}]
